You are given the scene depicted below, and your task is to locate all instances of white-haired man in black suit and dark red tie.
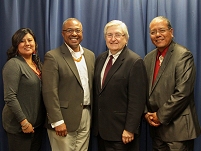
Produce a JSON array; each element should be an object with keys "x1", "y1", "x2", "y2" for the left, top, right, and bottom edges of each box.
[{"x1": 92, "y1": 20, "x2": 147, "y2": 151}]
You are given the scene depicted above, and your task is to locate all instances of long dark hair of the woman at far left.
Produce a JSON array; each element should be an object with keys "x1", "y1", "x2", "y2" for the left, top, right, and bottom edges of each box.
[{"x1": 7, "y1": 28, "x2": 42, "y2": 71}]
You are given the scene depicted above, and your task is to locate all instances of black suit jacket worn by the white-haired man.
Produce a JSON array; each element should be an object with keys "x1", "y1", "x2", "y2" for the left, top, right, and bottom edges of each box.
[{"x1": 93, "y1": 47, "x2": 147, "y2": 141}]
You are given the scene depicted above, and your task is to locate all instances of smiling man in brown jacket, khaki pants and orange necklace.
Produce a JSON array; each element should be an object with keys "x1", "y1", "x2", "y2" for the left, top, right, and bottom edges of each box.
[{"x1": 42, "y1": 18, "x2": 95, "y2": 151}]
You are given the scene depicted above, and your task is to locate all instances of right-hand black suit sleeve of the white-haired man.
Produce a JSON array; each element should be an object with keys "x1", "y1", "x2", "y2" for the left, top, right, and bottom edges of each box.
[{"x1": 125, "y1": 59, "x2": 148, "y2": 134}]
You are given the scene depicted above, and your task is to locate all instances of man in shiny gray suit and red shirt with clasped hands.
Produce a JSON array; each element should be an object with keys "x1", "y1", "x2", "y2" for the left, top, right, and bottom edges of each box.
[{"x1": 144, "y1": 16, "x2": 200, "y2": 151}]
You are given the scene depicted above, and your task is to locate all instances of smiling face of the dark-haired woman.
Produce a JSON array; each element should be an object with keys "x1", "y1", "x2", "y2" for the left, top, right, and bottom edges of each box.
[{"x1": 18, "y1": 33, "x2": 36, "y2": 58}]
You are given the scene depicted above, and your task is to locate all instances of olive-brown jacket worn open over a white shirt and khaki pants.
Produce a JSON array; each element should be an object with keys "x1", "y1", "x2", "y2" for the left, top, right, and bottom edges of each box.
[{"x1": 42, "y1": 44, "x2": 95, "y2": 132}]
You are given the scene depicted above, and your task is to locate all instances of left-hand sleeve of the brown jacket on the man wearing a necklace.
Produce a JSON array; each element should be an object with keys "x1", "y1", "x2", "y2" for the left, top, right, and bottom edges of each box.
[{"x1": 42, "y1": 52, "x2": 63, "y2": 123}]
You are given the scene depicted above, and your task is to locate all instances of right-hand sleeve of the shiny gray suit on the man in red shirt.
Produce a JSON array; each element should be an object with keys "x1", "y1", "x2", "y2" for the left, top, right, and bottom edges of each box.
[{"x1": 157, "y1": 51, "x2": 195, "y2": 125}]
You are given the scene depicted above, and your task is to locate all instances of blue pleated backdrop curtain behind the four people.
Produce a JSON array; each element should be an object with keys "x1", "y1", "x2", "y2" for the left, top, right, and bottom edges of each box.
[{"x1": 0, "y1": 0, "x2": 201, "y2": 151}]
